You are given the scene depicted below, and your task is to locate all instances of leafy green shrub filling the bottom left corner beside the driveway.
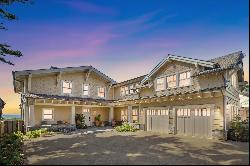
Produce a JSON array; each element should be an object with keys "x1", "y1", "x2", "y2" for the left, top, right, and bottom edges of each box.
[{"x1": 0, "y1": 132, "x2": 24, "y2": 165}]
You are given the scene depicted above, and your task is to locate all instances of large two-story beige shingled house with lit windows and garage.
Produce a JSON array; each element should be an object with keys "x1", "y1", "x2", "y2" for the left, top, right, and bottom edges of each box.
[{"x1": 12, "y1": 51, "x2": 244, "y2": 138}]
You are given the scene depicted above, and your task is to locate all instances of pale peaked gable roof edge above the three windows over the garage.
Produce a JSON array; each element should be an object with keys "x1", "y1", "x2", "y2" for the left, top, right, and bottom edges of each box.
[{"x1": 141, "y1": 54, "x2": 216, "y2": 83}]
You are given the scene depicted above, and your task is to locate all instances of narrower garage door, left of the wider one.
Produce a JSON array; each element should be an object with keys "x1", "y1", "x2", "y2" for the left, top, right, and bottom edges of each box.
[{"x1": 147, "y1": 109, "x2": 169, "y2": 133}]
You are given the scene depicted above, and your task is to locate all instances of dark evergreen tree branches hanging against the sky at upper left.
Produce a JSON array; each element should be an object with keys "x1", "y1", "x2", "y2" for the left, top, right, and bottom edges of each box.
[{"x1": 0, "y1": 0, "x2": 29, "y2": 65}]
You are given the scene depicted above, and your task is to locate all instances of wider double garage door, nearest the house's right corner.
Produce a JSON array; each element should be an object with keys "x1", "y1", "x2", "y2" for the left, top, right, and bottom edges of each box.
[{"x1": 177, "y1": 108, "x2": 212, "y2": 137}]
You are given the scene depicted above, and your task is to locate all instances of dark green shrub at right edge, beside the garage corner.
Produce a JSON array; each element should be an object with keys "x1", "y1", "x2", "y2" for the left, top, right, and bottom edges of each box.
[{"x1": 228, "y1": 115, "x2": 249, "y2": 142}]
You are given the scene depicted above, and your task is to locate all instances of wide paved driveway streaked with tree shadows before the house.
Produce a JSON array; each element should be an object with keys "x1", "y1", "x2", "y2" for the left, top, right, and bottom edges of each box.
[{"x1": 25, "y1": 131, "x2": 249, "y2": 164}]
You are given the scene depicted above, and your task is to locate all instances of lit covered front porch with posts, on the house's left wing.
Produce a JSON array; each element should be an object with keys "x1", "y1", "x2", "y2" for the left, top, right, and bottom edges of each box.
[{"x1": 23, "y1": 94, "x2": 114, "y2": 128}]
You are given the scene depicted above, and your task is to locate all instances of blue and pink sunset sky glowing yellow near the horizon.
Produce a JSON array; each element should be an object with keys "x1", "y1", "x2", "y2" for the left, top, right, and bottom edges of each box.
[{"x1": 0, "y1": 0, "x2": 249, "y2": 114}]
